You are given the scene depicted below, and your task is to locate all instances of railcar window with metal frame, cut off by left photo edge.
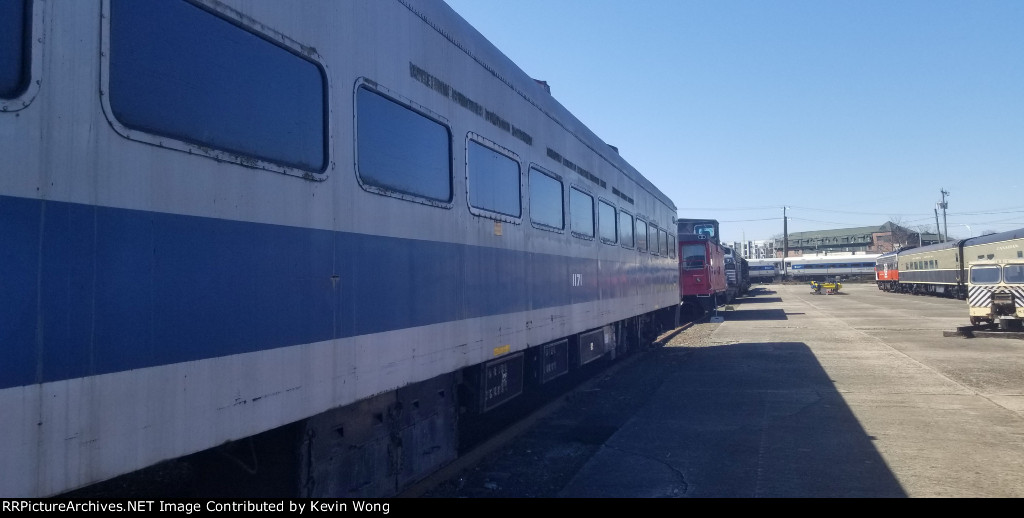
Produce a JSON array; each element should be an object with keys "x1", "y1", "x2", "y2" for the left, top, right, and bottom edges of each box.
[{"x1": 0, "y1": 0, "x2": 45, "y2": 113}]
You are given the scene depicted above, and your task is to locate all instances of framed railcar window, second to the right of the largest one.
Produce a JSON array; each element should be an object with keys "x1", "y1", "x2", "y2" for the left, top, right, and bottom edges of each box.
[{"x1": 466, "y1": 132, "x2": 523, "y2": 224}]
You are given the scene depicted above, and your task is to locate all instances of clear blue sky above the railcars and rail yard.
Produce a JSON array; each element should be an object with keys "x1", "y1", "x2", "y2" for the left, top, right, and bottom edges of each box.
[{"x1": 446, "y1": 0, "x2": 1024, "y2": 243}]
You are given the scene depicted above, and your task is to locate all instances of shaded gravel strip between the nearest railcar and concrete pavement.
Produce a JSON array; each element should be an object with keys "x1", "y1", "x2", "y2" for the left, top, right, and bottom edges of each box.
[{"x1": 407, "y1": 321, "x2": 720, "y2": 499}]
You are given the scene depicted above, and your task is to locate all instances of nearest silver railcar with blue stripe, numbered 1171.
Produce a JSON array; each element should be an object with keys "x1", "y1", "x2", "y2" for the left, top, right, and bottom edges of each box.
[{"x1": 6, "y1": 0, "x2": 679, "y2": 497}]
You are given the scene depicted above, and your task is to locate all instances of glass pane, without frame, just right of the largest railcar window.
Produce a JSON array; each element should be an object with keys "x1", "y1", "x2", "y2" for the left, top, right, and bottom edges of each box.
[{"x1": 355, "y1": 88, "x2": 452, "y2": 202}]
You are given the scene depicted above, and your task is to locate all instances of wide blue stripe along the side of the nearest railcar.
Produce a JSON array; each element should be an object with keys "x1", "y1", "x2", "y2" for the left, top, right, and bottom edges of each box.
[{"x1": 0, "y1": 197, "x2": 676, "y2": 388}]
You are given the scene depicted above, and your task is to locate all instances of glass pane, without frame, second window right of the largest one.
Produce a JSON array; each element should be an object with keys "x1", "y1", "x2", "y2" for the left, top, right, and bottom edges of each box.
[{"x1": 466, "y1": 140, "x2": 522, "y2": 218}]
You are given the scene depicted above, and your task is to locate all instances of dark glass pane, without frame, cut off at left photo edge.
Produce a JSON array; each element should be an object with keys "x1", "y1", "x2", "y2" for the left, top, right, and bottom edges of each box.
[{"x1": 0, "y1": 0, "x2": 32, "y2": 99}]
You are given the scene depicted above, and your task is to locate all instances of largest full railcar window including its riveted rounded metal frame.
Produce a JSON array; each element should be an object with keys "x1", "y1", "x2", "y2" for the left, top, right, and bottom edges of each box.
[{"x1": 100, "y1": 0, "x2": 332, "y2": 181}]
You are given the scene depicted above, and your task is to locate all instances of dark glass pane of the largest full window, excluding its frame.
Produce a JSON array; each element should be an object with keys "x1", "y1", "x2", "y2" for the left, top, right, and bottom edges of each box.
[{"x1": 110, "y1": 0, "x2": 327, "y2": 172}]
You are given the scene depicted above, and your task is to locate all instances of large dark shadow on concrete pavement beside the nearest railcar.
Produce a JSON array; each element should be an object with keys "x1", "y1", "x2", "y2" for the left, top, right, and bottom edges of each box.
[{"x1": 560, "y1": 343, "x2": 906, "y2": 498}]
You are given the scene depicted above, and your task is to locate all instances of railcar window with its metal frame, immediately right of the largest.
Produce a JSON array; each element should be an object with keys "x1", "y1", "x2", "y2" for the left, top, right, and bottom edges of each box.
[{"x1": 353, "y1": 83, "x2": 455, "y2": 209}]
